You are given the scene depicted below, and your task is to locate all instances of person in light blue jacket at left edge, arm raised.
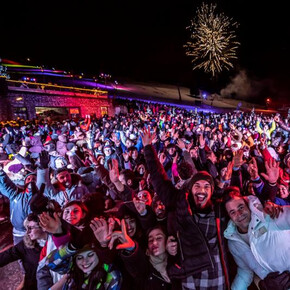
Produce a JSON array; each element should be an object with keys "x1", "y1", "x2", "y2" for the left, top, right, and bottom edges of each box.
[{"x1": 0, "y1": 168, "x2": 36, "y2": 245}]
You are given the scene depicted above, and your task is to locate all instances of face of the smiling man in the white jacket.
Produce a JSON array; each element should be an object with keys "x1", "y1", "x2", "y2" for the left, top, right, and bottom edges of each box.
[{"x1": 226, "y1": 197, "x2": 251, "y2": 233}]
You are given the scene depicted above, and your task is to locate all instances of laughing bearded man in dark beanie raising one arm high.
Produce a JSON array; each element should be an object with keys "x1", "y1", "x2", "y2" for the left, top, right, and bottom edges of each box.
[{"x1": 142, "y1": 129, "x2": 230, "y2": 290}]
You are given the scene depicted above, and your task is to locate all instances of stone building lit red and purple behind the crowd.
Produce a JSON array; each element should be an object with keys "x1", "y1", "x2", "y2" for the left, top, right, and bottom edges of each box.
[{"x1": 0, "y1": 63, "x2": 115, "y2": 121}]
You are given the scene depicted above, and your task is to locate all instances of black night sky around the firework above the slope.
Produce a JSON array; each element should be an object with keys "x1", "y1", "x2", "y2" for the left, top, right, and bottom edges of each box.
[{"x1": 0, "y1": 0, "x2": 290, "y2": 104}]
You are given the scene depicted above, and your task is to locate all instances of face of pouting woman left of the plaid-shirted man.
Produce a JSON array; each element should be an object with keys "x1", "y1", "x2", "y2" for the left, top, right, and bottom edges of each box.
[{"x1": 148, "y1": 229, "x2": 166, "y2": 257}]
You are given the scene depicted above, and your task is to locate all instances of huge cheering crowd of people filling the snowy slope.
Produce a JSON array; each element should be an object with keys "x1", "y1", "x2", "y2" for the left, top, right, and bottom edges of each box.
[{"x1": 0, "y1": 101, "x2": 290, "y2": 290}]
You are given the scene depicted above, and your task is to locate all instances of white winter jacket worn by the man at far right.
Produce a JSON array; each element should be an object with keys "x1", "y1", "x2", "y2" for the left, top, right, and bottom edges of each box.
[{"x1": 224, "y1": 196, "x2": 290, "y2": 290}]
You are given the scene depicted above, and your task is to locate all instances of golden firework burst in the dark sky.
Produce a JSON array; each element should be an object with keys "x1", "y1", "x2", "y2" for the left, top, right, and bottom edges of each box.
[{"x1": 184, "y1": 3, "x2": 240, "y2": 76}]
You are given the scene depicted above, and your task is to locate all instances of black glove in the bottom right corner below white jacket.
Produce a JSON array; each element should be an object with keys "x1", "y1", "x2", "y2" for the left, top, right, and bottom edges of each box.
[{"x1": 259, "y1": 271, "x2": 290, "y2": 290}]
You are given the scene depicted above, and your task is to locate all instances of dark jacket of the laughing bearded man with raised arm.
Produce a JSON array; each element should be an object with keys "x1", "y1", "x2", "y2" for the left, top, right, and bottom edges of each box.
[{"x1": 144, "y1": 145, "x2": 228, "y2": 286}]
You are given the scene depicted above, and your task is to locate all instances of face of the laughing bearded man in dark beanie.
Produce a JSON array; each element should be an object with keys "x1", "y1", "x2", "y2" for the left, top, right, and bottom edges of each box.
[{"x1": 191, "y1": 180, "x2": 212, "y2": 209}]
